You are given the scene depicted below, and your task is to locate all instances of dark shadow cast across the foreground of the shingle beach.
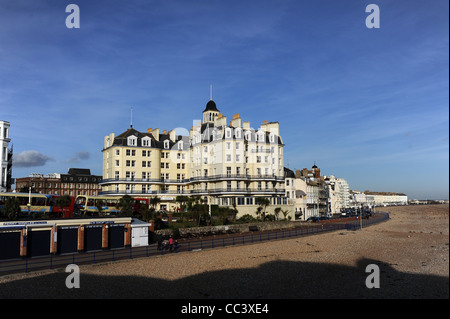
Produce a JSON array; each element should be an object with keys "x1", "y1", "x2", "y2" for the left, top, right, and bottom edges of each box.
[{"x1": 0, "y1": 259, "x2": 449, "y2": 299}]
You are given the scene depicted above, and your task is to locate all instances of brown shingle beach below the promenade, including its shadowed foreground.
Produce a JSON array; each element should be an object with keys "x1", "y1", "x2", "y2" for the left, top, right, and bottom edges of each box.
[{"x1": 0, "y1": 205, "x2": 449, "y2": 299}]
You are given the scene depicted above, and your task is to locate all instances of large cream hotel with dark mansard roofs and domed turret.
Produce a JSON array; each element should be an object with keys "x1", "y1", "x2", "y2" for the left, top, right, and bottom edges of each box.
[{"x1": 100, "y1": 99, "x2": 295, "y2": 219}]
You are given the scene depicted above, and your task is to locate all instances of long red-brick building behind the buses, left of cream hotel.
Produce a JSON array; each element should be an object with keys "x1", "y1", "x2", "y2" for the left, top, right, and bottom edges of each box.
[{"x1": 16, "y1": 168, "x2": 102, "y2": 196}]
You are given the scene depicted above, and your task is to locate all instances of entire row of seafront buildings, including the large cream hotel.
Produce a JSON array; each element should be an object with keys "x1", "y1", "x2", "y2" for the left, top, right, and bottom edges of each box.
[{"x1": 0, "y1": 99, "x2": 407, "y2": 220}]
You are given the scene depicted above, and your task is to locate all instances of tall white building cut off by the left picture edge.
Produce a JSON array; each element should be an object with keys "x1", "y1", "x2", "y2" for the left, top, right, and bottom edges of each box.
[{"x1": 0, "y1": 121, "x2": 12, "y2": 192}]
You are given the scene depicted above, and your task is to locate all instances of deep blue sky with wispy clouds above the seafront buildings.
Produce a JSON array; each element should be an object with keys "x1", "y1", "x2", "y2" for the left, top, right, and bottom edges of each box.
[{"x1": 0, "y1": 0, "x2": 449, "y2": 199}]
